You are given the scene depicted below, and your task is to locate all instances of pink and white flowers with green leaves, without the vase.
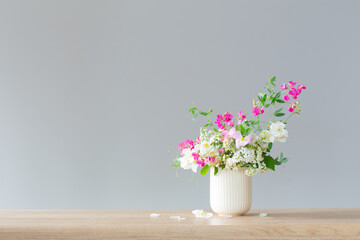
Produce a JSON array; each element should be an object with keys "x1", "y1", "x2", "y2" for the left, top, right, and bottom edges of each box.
[{"x1": 172, "y1": 77, "x2": 306, "y2": 176}]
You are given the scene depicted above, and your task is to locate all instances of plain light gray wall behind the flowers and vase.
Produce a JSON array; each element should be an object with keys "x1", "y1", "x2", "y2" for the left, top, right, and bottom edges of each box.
[{"x1": 0, "y1": 0, "x2": 360, "y2": 209}]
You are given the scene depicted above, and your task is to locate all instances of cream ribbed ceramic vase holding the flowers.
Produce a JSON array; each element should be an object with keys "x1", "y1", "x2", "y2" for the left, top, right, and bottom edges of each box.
[{"x1": 210, "y1": 168, "x2": 252, "y2": 216}]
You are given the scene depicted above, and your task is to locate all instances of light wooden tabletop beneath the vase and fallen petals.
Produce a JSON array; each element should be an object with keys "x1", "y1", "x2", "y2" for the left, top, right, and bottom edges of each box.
[{"x1": 0, "y1": 209, "x2": 360, "y2": 240}]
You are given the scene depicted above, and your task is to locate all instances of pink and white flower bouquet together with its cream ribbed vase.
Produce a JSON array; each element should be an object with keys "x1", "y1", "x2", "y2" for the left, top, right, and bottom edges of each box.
[{"x1": 172, "y1": 77, "x2": 306, "y2": 215}]
